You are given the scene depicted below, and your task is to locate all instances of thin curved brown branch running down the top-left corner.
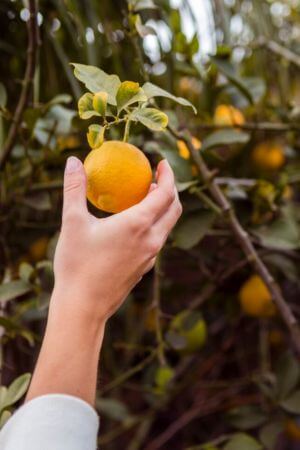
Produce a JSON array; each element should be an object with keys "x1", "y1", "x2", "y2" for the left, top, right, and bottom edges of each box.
[{"x1": 0, "y1": 0, "x2": 39, "y2": 170}]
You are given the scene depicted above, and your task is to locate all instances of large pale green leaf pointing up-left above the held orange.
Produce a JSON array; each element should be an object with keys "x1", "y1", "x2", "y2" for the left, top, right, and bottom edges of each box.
[{"x1": 72, "y1": 63, "x2": 121, "y2": 105}]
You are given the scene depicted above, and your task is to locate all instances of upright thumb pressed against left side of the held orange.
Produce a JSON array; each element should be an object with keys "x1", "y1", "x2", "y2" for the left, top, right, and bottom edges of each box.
[{"x1": 63, "y1": 156, "x2": 87, "y2": 219}]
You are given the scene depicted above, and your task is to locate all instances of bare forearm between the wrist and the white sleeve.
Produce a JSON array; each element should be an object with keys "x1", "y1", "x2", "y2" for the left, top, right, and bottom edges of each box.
[{"x1": 26, "y1": 293, "x2": 105, "y2": 404}]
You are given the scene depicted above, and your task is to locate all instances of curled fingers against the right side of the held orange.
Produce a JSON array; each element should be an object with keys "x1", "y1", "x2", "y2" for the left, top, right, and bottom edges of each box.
[{"x1": 128, "y1": 159, "x2": 175, "y2": 223}]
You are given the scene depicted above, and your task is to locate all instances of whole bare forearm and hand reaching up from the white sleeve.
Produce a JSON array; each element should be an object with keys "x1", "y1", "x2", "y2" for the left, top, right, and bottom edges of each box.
[{"x1": 26, "y1": 157, "x2": 181, "y2": 404}]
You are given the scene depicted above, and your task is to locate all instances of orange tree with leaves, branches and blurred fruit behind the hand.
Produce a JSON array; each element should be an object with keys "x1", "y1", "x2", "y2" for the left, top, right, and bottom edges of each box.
[{"x1": 0, "y1": 0, "x2": 300, "y2": 450}]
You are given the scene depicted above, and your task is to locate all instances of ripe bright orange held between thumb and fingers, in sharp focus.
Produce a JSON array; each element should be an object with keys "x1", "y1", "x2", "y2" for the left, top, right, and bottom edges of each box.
[{"x1": 84, "y1": 141, "x2": 152, "y2": 213}]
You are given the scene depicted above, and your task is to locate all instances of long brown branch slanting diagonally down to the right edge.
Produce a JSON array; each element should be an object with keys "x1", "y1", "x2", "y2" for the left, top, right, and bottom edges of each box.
[{"x1": 168, "y1": 126, "x2": 300, "y2": 354}]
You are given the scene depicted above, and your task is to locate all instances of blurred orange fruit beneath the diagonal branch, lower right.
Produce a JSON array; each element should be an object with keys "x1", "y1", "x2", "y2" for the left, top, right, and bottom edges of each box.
[{"x1": 239, "y1": 275, "x2": 276, "y2": 317}]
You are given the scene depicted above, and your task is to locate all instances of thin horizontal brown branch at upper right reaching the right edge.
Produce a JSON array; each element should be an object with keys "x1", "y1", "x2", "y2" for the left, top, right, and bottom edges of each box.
[{"x1": 196, "y1": 122, "x2": 300, "y2": 133}]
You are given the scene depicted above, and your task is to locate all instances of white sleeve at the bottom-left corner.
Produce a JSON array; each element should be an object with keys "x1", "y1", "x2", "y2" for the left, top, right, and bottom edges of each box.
[{"x1": 0, "y1": 394, "x2": 99, "y2": 450}]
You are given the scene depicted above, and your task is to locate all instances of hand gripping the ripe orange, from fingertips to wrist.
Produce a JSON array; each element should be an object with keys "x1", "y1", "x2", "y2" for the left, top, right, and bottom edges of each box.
[{"x1": 51, "y1": 157, "x2": 182, "y2": 322}]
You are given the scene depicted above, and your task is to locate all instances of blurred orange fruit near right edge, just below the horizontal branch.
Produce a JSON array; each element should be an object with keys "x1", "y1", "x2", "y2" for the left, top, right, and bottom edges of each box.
[{"x1": 251, "y1": 141, "x2": 285, "y2": 170}]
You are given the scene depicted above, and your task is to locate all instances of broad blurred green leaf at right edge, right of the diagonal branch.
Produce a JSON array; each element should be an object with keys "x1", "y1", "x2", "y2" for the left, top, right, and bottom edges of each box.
[{"x1": 252, "y1": 206, "x2": 300, "y2": 250}]
